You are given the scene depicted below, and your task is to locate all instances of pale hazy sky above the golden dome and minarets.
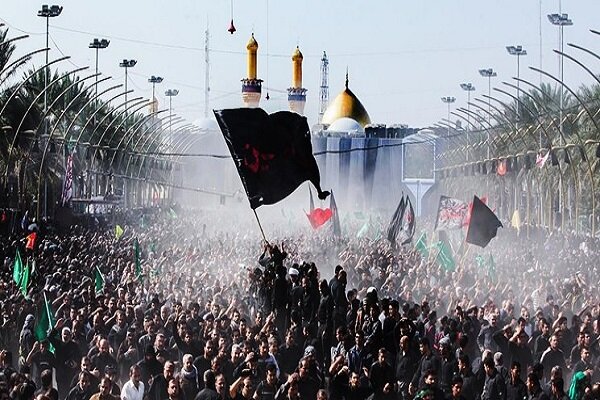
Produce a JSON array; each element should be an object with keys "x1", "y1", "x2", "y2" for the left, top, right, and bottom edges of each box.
[{"x1": 0, "y1": 0, "x2": 600, "y2": 127}]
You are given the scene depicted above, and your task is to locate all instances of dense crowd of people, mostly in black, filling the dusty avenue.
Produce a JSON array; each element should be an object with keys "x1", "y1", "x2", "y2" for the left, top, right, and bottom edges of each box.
[{"x1": 0, "y1": 205, "x2": 600, "y2": 400}]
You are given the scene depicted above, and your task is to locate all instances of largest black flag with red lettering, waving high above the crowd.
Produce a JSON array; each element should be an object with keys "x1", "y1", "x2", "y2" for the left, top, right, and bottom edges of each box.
[{"x1": 214, "y1": 108, "x2": 329, "y2": 209}]
